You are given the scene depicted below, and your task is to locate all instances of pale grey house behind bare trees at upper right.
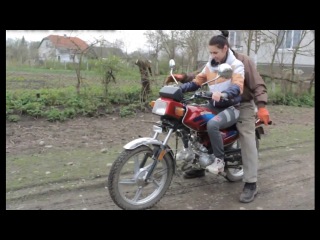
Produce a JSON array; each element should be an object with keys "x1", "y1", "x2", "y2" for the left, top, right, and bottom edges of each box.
[{"x1": 198, "y1": 30, "x2": 315, "y2": 75}]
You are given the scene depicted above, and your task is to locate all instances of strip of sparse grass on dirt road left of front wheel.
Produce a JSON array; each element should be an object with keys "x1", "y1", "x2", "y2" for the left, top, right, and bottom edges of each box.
[{"x1": 6, "y1": 147, "x2": 122, "y2": 192}]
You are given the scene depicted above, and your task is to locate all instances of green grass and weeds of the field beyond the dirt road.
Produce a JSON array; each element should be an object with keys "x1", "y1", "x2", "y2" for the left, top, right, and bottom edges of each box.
[{"x1": 6, "y1": 64, "x2": 314, "y2": 121}]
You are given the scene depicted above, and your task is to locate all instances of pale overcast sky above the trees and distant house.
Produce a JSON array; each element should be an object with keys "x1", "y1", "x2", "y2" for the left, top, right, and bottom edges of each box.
[{"x1": 6, "y1": 30, "x2": 148, "y2": 53}]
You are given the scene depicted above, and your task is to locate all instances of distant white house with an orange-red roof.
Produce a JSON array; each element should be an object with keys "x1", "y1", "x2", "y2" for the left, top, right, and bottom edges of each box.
[{"x1": 38, "y1": 35, "x2": 89, "y2": 63}]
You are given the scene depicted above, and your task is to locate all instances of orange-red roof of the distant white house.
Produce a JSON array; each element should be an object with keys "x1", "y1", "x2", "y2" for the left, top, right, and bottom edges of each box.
[{"x1": 40, "y1": 35, "x2": 89, "y2": 51}]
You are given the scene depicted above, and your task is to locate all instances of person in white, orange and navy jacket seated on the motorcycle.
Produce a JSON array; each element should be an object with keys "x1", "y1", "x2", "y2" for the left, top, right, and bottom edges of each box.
[{"x1": 176, "y1": 32, "x2": 244, "y2": 174}]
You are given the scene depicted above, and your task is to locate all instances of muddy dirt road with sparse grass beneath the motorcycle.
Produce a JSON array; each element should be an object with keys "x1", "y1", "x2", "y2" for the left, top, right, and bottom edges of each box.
[{"x1": 6, "y1": 106, "x2": 315, "y2": 210}]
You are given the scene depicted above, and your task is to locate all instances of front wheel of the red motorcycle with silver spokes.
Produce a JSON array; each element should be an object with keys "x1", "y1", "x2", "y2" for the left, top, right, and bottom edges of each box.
[{"x1": 107, "y1": 145, "x2": 174, "y2": 210}]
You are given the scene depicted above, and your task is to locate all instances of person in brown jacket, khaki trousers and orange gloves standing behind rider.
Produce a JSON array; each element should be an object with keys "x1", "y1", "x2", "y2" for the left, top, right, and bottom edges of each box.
[{"x1": 166, "y1": 44, "x2": 270, "y2": 203}]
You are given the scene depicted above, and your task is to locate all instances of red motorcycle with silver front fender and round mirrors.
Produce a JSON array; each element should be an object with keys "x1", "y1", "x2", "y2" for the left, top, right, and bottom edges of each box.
[{"x1": 107, "y1": 59, "x2": 272, "y2": 210}]
